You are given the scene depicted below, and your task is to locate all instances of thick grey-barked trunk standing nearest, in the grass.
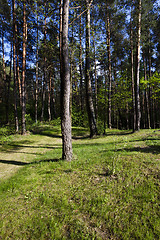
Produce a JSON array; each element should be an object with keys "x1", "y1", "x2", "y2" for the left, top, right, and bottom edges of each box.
[{"x1": 60, "y1": 0, "x2": 72, "y2": 161}]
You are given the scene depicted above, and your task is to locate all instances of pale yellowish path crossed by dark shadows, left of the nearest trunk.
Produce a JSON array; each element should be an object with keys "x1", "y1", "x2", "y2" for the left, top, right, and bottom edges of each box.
[{"x1": 0, "y1": 135, "x2": 61, "y2": 181}]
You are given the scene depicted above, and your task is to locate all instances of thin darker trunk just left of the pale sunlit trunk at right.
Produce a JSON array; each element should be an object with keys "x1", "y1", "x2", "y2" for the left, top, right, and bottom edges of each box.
[{"x1": 130, "y1": 6, "x2": 136, "y2": 132}]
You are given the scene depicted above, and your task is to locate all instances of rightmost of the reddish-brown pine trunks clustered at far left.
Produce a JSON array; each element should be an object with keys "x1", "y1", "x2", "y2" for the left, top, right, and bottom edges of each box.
[{"x1": 22, "y1": 0, "x2": 27, "y2": 135}]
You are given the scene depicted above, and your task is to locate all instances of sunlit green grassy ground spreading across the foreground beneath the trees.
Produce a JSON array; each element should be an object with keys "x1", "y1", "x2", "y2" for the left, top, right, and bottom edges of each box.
[{"x1": 0, "y1": 126, "x2": 160, "y2": 240}]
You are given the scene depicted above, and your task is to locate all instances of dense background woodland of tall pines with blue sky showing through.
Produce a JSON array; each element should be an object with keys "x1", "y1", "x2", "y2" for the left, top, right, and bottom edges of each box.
[{"x1": 0, "y1": 0, "x2": 160, "y2": 133}]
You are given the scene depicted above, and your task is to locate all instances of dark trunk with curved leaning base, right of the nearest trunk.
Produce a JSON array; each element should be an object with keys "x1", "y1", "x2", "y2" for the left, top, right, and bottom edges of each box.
[{"x1": 85, "y1": 0, "x2": 97, "y2": 137}]
